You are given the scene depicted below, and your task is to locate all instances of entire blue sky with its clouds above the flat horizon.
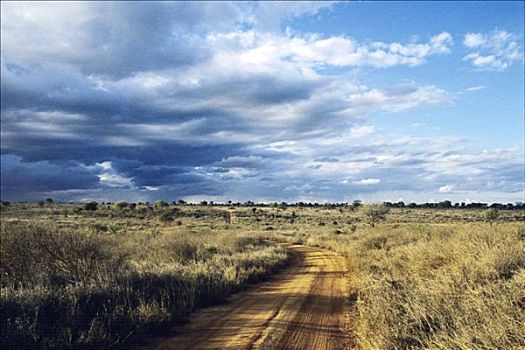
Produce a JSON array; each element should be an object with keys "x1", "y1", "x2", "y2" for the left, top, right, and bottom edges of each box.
[{"x1": 1, "y1": 1, "x2": 525, "y2": 203}]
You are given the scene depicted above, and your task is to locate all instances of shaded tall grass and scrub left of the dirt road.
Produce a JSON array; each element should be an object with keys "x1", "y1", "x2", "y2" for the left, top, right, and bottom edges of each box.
[{"x1": 0, "y1": 222, "x2": 287, "y2": 349}]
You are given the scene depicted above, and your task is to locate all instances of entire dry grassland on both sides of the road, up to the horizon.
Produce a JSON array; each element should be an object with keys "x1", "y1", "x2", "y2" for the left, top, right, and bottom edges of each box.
[{"x1": 0, "y1": 201, "x2": 525, "y2": 349}]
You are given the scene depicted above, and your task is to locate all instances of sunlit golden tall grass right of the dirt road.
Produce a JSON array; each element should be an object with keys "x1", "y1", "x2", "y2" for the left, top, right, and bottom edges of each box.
[{"x1": 274, "y1": 220, "x2": 525, "y2": 350}]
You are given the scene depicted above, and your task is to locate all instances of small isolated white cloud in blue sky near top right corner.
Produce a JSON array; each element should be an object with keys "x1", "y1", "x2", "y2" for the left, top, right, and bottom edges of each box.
[{"x1": 463, "y1": 29, "x2": 523, "y2": 71}]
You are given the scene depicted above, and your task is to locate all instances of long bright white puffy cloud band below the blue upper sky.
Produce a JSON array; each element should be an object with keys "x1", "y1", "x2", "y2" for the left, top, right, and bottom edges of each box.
[{"x1": 208, "y1": 31, "x2": 453, "y2": 69}]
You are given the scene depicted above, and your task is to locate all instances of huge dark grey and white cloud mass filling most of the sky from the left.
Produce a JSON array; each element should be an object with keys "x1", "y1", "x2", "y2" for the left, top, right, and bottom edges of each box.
[{"x1": 0, "y1": 2, "x2": 522, "y2": 201}]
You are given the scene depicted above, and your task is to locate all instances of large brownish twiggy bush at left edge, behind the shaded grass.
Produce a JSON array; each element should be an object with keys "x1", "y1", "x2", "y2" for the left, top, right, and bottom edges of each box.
[{"x1": 0, "y1": 223, "x2": 119, "y2": 287}]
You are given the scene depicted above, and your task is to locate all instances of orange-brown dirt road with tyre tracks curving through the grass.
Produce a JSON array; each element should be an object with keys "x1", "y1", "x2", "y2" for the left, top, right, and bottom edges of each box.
[{"x1": 141, "y1": 245, "x2": 351, "y2": 350}]
